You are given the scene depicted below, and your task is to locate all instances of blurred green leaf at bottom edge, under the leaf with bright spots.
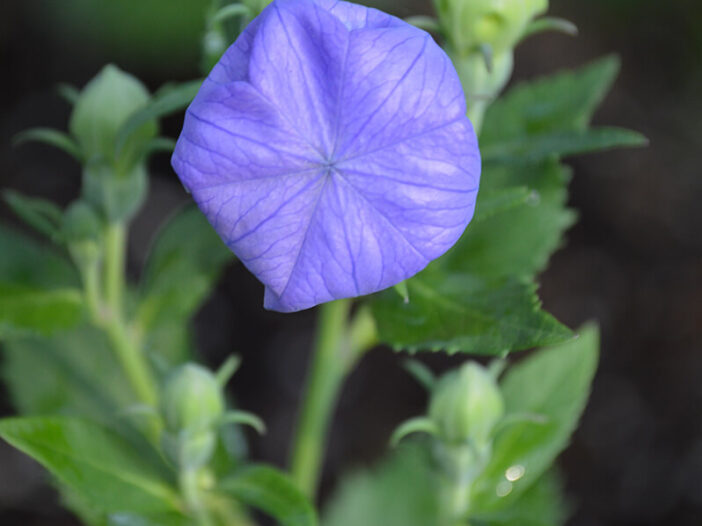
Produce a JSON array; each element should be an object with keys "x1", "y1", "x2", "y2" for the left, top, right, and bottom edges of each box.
[{"x1": 471, "y1": 470, "x2": 569, "y2": 526}]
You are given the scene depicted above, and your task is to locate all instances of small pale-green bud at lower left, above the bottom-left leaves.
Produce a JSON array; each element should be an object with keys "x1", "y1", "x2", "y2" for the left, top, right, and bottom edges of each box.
[{"x1": 161, "y1": 363, "x2": 225, "y2": 436}]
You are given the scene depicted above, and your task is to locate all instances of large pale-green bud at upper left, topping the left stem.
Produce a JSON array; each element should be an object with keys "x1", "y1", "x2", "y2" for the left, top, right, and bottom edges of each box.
[{"x1": 68, "y1": 65, "x2": 157, "y2": 167}]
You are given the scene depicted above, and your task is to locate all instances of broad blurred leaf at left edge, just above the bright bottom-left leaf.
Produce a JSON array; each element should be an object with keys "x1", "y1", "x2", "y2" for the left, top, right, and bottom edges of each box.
[{"x1": 0, "y1": 326, "x2": 136, "y2": 428}]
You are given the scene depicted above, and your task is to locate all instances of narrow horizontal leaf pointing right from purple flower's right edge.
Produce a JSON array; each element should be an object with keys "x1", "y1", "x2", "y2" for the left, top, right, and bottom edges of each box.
[{"x1": 481, "y1": 128, "x2": 648, "y2": 162}]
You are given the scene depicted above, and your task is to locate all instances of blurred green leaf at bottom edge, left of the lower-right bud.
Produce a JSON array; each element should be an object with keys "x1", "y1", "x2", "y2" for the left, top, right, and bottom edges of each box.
[{"x1": 322, "y1": 444, "x2": 440, "y2": 526}]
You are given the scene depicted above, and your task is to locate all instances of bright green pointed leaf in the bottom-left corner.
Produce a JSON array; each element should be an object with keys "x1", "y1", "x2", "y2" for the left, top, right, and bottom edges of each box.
[{"x1": 0, "y1": 417, "x2": 179, "y2": 513}]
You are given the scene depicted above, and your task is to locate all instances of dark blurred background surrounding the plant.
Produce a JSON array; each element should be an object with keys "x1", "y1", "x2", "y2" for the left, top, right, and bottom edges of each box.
[{"x1": 0, "y1": 0, "x2": 702, "y2": 526}]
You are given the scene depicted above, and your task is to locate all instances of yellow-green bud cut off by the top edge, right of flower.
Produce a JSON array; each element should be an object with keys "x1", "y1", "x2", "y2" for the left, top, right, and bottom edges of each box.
[{"x1": 435, "y1": 0, "x2": 548, "y2": 55}]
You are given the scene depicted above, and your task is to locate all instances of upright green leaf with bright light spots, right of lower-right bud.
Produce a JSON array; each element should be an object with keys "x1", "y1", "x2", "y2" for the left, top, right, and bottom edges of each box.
[{"x1": 473, "y1": 326, "x2": 599, "y2": 514}]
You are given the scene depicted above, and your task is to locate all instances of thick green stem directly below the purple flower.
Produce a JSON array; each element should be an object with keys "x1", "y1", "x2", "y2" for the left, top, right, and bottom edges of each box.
[{"x1": 290, "y1": 299, "x2": 351, "y2": 496}]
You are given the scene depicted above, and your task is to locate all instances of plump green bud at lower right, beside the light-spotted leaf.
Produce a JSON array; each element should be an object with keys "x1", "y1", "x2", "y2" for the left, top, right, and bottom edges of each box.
[{"x1": 429, "y1": 362, "x2": 504, "y2": 448}]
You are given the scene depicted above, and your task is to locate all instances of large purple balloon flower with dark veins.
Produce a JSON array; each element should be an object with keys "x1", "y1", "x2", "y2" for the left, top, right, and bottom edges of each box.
[{"x1": 173, "y1": 0, "x2": 480, "y2": 312}]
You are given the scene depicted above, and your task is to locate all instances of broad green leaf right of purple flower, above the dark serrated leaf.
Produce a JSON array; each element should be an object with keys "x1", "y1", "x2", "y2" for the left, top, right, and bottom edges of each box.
[{"x1": 446, "y1": 161, "x2": 575, "y2": 279}]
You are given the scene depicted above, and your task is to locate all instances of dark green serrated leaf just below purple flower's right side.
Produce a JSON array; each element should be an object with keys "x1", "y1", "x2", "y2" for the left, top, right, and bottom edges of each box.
[{"x1": 372, "y1": 269, "x2": 572, "y2": 355}]
